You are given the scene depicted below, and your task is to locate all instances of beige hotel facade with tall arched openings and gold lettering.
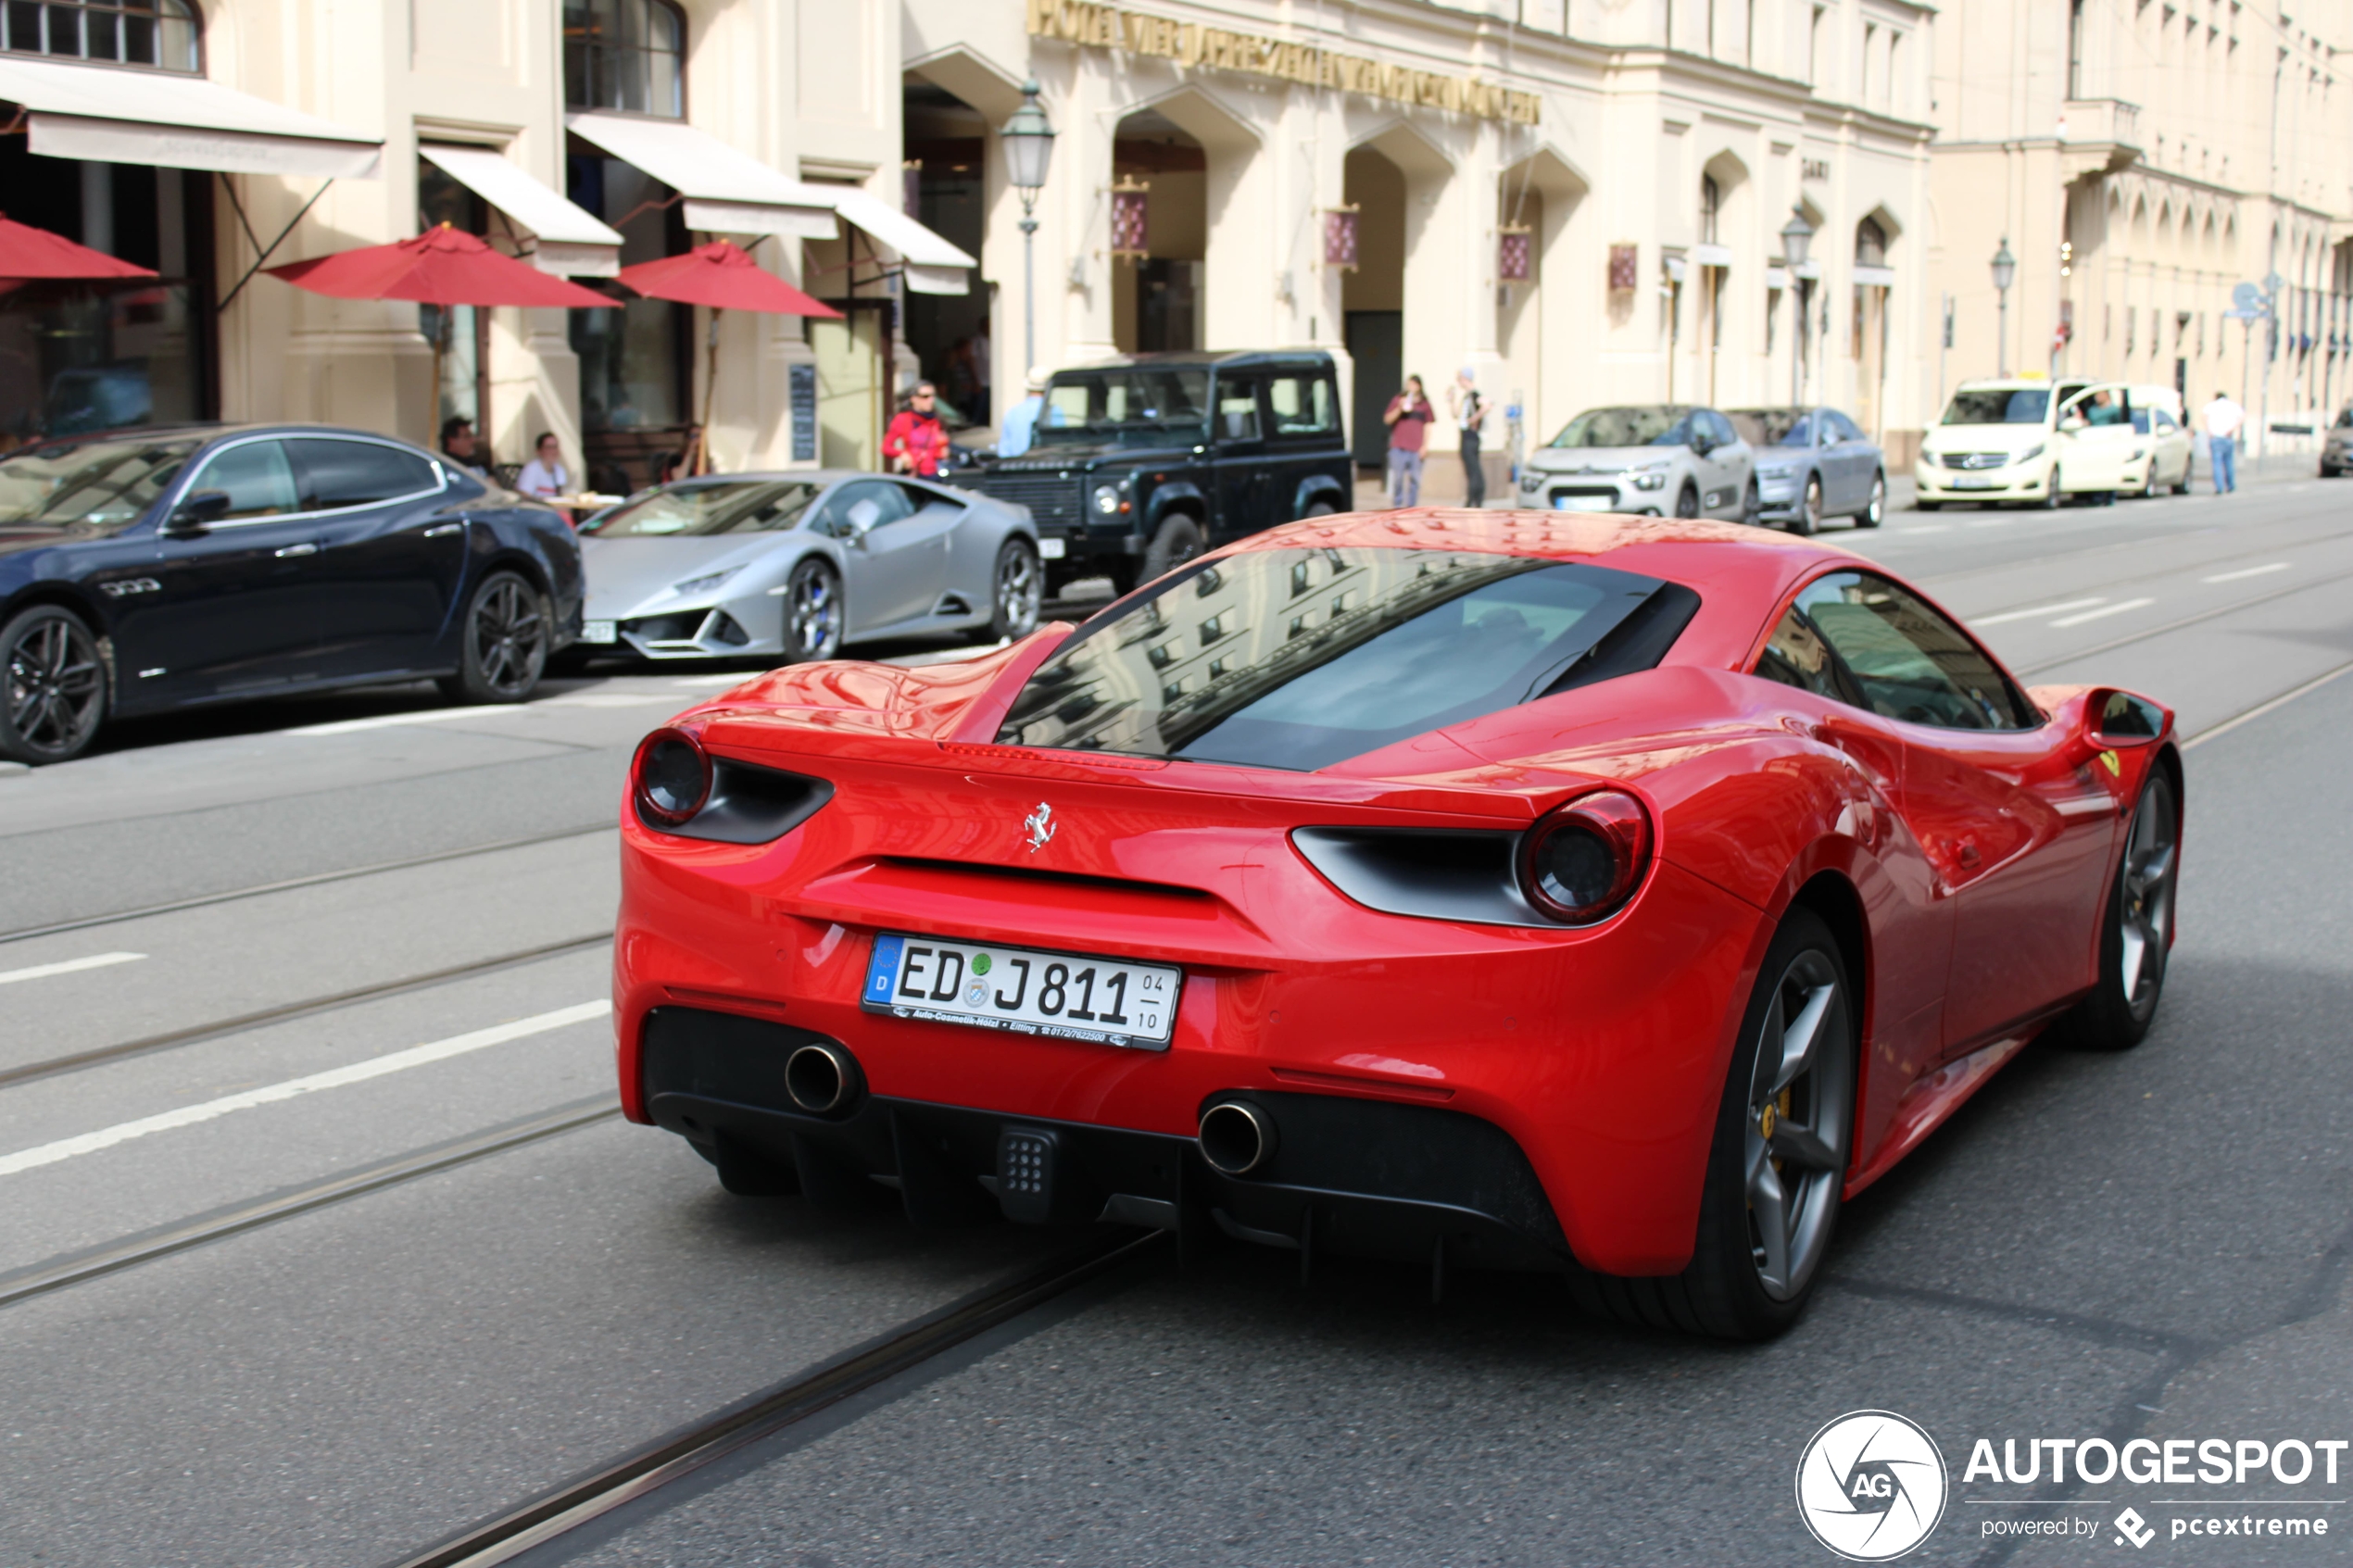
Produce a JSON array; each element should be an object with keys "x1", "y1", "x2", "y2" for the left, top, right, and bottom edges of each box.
[{"x1": 903, "y1": 0, "x2": 1936, "y2": 479}]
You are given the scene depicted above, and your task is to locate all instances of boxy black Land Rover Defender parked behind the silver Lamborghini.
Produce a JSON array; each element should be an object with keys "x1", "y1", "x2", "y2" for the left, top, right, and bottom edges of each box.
[{"x1": 955, "y1": 350, "x2": 1355, "y2": 595}]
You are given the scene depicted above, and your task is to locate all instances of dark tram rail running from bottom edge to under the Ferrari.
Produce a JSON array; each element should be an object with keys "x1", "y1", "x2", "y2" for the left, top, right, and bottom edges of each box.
[{"x1": 388, "y1": 1229, "x2": 1167, "y2": 1568}]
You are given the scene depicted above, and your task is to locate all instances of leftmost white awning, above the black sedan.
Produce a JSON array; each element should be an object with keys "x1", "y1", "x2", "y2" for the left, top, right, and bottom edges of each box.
[{"x1": 0, "y1": 54, "x2": 384, "y2": 179}]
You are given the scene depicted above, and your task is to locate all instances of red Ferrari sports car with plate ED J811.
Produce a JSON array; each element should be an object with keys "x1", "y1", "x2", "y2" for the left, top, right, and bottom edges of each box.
[{"x1": 614, "y1": 510, "x2": 2182, "y2": 1337}]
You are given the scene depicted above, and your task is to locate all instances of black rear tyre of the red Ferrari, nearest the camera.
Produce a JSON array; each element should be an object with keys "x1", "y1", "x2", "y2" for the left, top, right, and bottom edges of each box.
[{"x1": 1572, "y1": 905, "x2": 1856, "y2": 1340}]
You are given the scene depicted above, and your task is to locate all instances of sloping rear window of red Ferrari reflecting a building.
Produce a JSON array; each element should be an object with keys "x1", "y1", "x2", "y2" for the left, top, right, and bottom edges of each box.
[{"x1": 998, "y1": 547, "x2": 1699, "y2": 769}]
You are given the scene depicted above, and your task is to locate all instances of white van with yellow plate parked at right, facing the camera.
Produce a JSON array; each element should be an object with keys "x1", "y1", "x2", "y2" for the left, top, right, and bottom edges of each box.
[{"x1": 1913, "y1": 376, "x2": 2148, "y2": 512}]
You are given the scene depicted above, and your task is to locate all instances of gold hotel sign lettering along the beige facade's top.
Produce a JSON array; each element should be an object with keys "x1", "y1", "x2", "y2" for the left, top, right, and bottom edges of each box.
[{"x1": 1028, "y1": 0, "x2": 1537, "y2": 125}]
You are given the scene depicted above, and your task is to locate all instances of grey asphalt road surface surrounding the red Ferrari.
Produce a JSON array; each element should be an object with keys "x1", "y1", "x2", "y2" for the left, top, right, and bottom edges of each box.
[{"x1": 0, "y1": 482, "x2": 2353, "y2": 1568}]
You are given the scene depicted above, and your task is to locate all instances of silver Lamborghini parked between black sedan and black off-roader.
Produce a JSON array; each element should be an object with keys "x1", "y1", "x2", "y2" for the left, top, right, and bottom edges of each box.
[{"x1": 581, "y1": 470, "x2": 1045, "y2": 663}]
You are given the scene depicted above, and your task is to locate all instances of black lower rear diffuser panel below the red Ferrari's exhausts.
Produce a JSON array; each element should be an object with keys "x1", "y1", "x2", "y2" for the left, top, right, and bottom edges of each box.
[{"x1": 640, "y1": 1006, "x2": 1569, "y2": 1270}]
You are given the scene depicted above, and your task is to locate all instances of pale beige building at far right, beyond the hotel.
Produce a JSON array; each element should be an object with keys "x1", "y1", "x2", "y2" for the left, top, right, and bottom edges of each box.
[{"x1": 1930, "y1": 0, "x2": 2353, "y2": 449}]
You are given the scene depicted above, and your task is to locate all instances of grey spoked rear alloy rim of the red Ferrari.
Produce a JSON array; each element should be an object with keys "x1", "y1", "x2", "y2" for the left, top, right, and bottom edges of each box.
[{"x1": 1742, "y1": 947, "x2": 1855, "y2": 1300}]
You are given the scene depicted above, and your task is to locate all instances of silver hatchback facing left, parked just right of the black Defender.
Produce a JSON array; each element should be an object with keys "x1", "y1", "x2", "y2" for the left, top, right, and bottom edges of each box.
[{"x1": 1520, "y1": 402, "x2": 1762, "y2": 521}]
